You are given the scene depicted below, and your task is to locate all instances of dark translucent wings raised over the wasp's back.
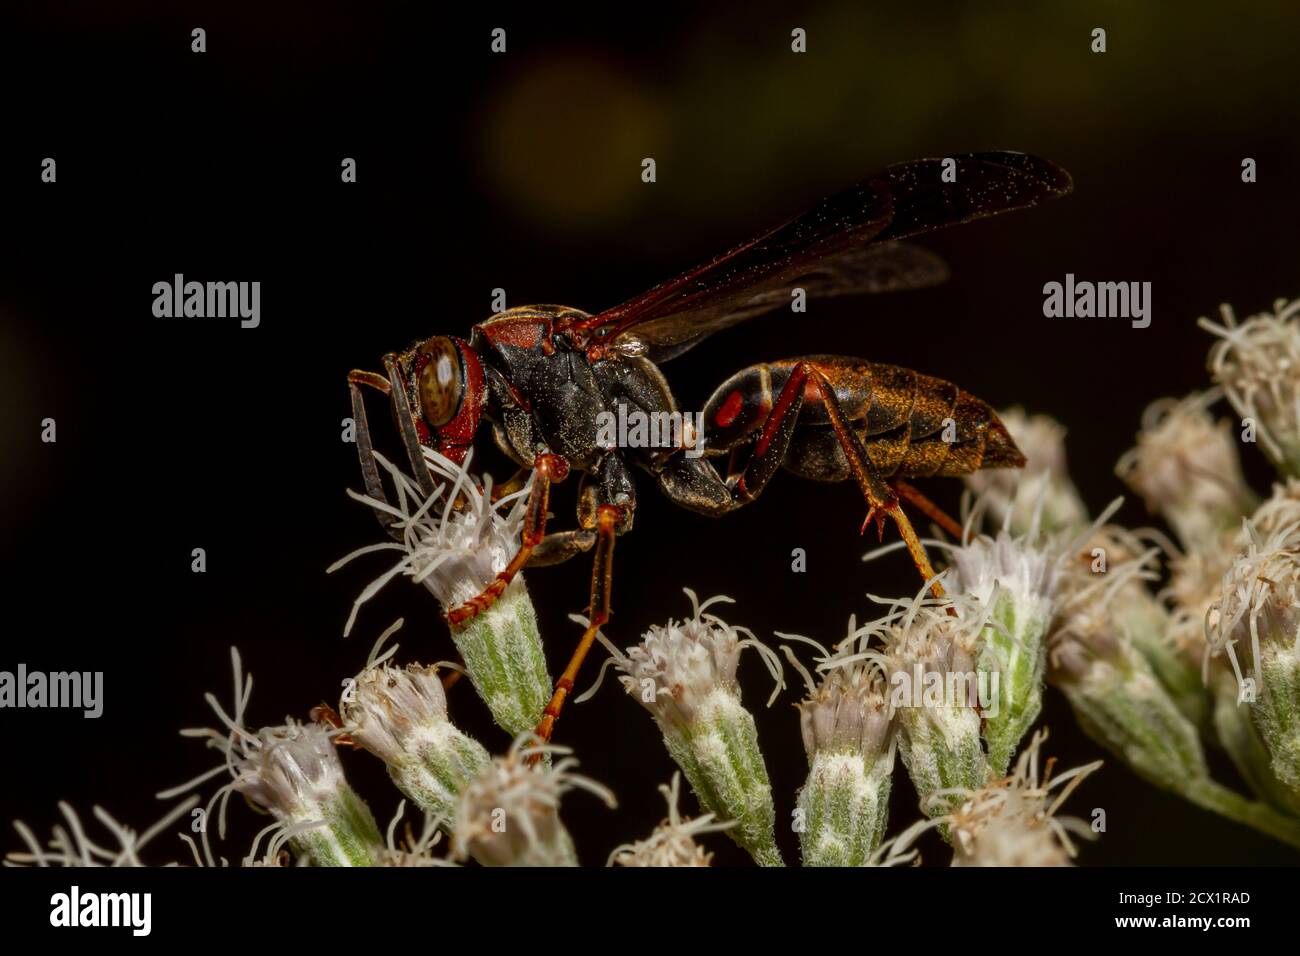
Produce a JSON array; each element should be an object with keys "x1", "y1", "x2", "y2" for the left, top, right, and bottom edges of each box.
[{"x1": 576, "y1": 152, "x2": 1071, "y2": 362}]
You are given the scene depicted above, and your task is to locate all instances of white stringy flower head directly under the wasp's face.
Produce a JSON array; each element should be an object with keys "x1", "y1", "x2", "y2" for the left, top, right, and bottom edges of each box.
[{"x1": 329, "y1": 447, "x2": 532, "y2": 636}]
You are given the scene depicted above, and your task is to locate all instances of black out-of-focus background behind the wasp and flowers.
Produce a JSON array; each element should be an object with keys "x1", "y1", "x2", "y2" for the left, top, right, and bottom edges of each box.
[{"x1": 0, "y1": 1, "x2": 1300, "y2": 865}]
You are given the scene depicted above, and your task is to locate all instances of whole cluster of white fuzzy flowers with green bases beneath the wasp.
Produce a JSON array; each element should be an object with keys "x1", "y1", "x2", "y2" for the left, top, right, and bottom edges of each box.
[{"x1": 20, "y1": 293, "x2": 1300, "y2": 868}]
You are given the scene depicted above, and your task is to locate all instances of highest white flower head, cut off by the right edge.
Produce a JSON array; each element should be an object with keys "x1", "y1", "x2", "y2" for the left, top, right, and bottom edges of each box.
[{"x1": 1199, "y1": 299, "x2": 1300, "y2": 475}]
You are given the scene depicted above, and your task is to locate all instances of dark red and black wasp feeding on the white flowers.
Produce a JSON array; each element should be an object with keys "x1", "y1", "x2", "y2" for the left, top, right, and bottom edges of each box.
[{"x1": 348, "y1": 152, "x2": 1071, "y2": 740}]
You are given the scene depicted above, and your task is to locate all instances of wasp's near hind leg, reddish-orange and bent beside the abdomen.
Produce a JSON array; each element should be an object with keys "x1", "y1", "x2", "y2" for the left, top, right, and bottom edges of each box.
[{"x1": 659, "y1": 359, "x2": 956, "y2": 597}]
